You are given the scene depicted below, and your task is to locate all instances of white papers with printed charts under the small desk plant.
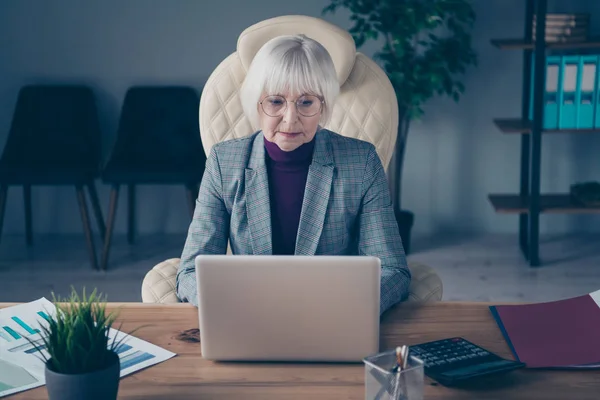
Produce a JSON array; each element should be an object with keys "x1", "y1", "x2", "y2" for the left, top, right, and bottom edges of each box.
[{"x1": 0, "y1": 298, "x2": 175, "y2": 397}]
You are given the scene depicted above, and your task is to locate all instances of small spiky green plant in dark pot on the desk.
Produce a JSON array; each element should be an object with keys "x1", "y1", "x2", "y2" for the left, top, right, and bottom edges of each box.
[{"x1": 27, "y1": 289, "x2": 129, "y2": 400}]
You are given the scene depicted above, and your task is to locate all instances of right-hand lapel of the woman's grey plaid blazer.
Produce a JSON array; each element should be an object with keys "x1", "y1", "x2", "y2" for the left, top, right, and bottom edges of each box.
[{"x1": 295, "y1": 131, "x2": 334, "y2": 255}]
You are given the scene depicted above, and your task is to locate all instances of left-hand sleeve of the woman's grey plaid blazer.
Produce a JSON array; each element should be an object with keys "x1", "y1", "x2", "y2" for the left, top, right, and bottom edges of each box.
[{"x1": 176, "y1": 145, "x2": 230, "y2": 306}]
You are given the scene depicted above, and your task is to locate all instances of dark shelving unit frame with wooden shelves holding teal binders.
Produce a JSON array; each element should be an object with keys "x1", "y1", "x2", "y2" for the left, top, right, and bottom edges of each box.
[{"x1": 489, "y1": 0, "x2": 600, "y2": 267}]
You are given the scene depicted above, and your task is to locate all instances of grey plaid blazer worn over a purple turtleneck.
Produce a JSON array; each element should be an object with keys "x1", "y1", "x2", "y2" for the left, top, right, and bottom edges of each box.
[{"x1": 177, "y1": 129, "x2": 411, "y2": 314}]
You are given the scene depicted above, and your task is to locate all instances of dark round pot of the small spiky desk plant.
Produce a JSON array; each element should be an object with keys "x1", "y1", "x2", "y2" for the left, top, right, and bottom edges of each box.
[{"x1": 45, "y1": 352, "x2": 121, "y2": 400}]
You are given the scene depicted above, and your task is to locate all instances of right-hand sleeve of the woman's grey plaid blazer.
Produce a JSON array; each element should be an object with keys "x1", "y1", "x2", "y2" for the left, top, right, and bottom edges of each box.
[{"x1": 358, "y1": 145, "x2": 411, "y2": 315}]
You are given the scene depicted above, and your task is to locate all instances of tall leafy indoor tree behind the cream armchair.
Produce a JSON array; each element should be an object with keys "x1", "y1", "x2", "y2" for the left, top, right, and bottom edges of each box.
[{"x1": 322, "y1": 0, "x2": 477, "y2": 253}]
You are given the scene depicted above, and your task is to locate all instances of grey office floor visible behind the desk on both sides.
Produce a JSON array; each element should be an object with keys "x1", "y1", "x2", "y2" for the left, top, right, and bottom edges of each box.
[{"x1": 0, "y1": 234, "x2": 600, "y2": 302}]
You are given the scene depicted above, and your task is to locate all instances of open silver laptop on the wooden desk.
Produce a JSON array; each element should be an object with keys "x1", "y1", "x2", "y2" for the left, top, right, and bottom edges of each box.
[{"x1": 196, "y1": 255, "x2": 381, "y2": 362}]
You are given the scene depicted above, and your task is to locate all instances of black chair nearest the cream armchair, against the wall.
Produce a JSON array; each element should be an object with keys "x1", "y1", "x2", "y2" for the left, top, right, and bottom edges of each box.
[{"x1": 101, "y1": 86, "x2": 206, "y2": 269}]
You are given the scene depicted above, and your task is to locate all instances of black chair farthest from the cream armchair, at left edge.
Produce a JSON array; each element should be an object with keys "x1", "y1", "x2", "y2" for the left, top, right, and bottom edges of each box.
[{"x1": 0, "y1": 85, "x2": 106, "y2": 269}]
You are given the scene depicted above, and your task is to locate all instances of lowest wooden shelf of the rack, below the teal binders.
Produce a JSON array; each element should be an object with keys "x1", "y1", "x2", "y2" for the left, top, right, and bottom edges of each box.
[{"x1": 489, "y1": 194, "x2": 600, "y2": 214}]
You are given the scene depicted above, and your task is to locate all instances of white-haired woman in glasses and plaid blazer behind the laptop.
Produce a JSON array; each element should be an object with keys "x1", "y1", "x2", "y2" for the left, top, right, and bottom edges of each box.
[{"x1": 177, "y1": 35, "x2": 411, "y2": 313}]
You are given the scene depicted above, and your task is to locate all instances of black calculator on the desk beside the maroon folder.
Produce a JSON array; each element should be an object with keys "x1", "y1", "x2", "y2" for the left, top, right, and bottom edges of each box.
[{"x1": 410, "y1": 337, "x2": 525, "y2": 386}]
